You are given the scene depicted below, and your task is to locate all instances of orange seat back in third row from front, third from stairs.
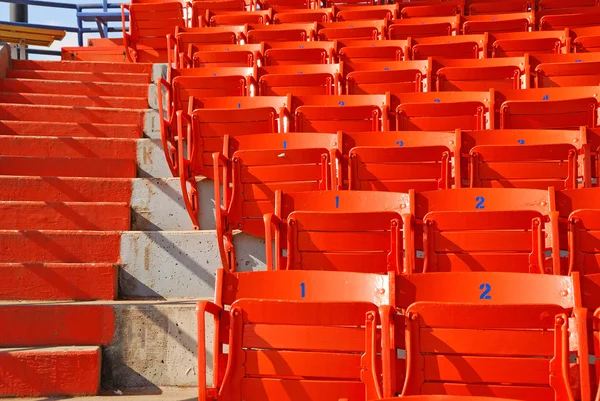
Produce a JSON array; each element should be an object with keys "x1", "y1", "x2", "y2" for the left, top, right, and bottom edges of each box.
[{"x1": 460, "y1": 130, "x2": 589, "y2": 189}]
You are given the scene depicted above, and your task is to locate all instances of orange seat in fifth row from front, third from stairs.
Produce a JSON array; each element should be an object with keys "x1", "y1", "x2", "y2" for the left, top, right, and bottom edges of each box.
[{"x1": 344, "y1": 60, "x2": 432, "y2": 95}]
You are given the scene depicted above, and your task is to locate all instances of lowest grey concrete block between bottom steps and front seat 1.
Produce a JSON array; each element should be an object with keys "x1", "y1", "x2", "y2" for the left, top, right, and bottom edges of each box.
[{"x1": 102, "y1": 301, "x2": 205, "y2": 393}]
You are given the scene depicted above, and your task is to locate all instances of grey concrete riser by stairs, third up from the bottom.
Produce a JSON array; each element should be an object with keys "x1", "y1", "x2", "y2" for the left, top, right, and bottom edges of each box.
[{"x1": 131, "y1": 178, "x2": 215, "y2": 231}]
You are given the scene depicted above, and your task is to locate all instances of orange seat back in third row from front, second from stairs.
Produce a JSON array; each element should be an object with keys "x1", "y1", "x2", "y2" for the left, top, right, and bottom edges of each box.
[{"x1": 338, "y1": 131, "x2": 456, "y2": 192}]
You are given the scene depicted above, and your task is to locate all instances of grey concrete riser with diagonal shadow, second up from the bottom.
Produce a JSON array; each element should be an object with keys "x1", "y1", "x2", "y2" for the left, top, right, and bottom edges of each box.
[{"x1": 119, "y1": 230, "x2": 265, "y2": 299}]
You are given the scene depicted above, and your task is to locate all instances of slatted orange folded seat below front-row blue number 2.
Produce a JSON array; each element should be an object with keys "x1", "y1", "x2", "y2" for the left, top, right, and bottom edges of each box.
[{"x1": 402, "y1": 302, "x2": 573, "y2": 401}]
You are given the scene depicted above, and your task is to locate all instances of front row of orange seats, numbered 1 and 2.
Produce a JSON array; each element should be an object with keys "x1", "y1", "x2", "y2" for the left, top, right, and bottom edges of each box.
[{"x1": 197, "y1": 266, "x2": 600, "y2": 401}]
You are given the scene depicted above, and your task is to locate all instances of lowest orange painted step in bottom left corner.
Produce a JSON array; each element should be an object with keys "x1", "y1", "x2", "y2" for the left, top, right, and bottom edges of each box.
[{"x1": 0, "y1": 347, "x2": 102, "y2": 397}]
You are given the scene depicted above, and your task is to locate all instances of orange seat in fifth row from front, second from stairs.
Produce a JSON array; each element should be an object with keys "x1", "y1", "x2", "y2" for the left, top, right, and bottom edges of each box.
[{"x1": 257, "y1": 64, "x2": 342, "y2": 96}]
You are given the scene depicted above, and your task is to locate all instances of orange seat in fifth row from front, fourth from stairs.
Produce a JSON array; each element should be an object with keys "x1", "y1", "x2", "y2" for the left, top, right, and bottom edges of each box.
[{"x1": 431, "y1": 57, "x2": 529, "y2": 92}]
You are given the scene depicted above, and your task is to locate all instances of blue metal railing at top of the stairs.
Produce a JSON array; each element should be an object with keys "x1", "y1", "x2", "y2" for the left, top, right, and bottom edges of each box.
[{"x1": 0, "y1": 0, "x2": 126, "y2": 56}]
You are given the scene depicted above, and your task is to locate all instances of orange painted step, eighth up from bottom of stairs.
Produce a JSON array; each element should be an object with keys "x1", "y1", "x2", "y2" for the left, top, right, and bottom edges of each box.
[{"x1": 0, "y1": 135, "x2": 137, "y2": 160}]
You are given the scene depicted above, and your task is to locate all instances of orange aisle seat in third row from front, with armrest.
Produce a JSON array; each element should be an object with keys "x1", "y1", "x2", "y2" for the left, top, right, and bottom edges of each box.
[{"x1": 213, "y1": 133, "x2": 337, "y2": 271}]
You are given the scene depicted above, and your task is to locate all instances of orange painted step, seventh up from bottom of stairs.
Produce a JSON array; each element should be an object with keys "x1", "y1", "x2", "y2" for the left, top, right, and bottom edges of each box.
[{"x1": 0, "y1": 156, "x2": 137, "y2": 178}]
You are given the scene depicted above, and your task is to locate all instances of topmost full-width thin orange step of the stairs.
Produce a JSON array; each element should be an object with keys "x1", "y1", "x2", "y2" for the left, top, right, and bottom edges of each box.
[{"x1": 12, "y1": 59, "x2": 152, "y2": 75}]
